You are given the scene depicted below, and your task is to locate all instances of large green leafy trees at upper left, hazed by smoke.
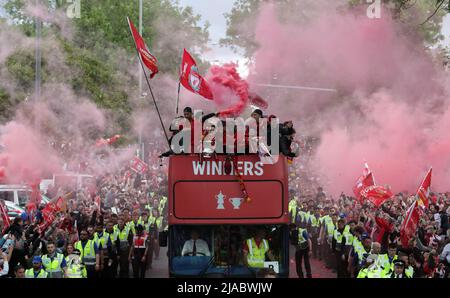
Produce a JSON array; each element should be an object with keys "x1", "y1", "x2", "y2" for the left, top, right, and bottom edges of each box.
[{"x1": 0, "y1": 0, "x2": 209, "y2": 130}]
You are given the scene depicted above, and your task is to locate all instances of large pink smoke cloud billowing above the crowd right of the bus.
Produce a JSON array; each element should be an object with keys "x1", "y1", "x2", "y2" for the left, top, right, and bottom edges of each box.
[{"x1": 249, "y1": 4, "x2": 450, "y2": 195}]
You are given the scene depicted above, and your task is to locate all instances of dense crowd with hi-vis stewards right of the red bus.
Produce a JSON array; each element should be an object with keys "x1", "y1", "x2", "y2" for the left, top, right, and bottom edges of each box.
[{"x1": 289, "y1": 187, "x2": 450, "y2": 278}]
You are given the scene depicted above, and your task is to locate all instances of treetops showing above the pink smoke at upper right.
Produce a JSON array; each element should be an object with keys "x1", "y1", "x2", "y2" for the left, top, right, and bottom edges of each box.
[{"x1": 221, "y1": 0, "x2": 450, "y2": 58}]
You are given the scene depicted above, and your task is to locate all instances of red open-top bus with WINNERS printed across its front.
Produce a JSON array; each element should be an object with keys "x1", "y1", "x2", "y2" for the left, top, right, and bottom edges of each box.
[{"x1": 164, "y1": 154, "x2": 289, "y2": 277}]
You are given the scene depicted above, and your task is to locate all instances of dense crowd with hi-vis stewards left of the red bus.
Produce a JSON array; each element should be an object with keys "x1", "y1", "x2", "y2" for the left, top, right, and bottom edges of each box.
[{"x1": 0, "y1": 151, "x2": 168, "y2": 278}]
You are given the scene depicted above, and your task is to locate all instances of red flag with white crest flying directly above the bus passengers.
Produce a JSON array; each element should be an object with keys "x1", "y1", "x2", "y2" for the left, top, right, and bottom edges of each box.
[{"x1": 180, "y1": 49, "x2": 213, "y2": 100}]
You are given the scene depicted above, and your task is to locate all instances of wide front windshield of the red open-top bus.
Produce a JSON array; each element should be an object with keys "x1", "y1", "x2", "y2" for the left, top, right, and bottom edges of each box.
[{"x1": 170, "y1": 225, "x2": 289, "y2": 277}]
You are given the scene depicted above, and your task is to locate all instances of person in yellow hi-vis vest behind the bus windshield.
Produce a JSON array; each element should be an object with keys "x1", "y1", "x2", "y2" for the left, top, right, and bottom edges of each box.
[{"x1": 243, "y1": 228, "x2": 275, "y2": 268}]
